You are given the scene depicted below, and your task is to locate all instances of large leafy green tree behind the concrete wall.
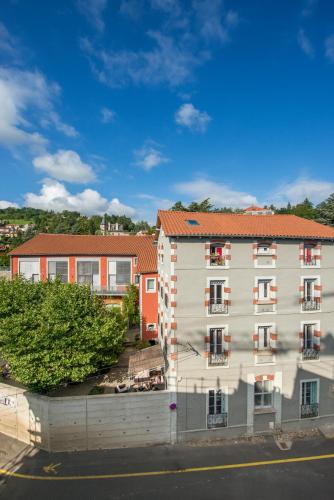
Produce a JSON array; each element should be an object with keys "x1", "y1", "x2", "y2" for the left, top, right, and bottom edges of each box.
[{"x1": 0, "y1": 278, "x2": 126, "y2": 392}]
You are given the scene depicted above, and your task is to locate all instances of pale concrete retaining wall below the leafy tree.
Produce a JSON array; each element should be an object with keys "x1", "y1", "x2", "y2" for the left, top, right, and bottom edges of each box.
[{"x1": 0, "y1": 384, "x2": 174, "y2": 451}]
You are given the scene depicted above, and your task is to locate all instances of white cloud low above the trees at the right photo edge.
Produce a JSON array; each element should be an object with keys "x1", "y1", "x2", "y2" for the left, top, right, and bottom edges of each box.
[{"x1": 268, "y1": 177, "x2": 334, "y2": 206}]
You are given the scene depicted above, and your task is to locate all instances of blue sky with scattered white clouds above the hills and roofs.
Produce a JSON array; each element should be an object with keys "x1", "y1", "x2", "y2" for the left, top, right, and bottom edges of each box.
[{"x1": 0, "y1": 0, "x2": 334, "y2": 221}]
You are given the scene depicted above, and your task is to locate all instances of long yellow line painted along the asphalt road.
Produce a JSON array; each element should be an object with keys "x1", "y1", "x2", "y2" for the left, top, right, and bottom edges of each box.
[{"x1": 0, "y1": 453, "x2": 334, "y2": 481}]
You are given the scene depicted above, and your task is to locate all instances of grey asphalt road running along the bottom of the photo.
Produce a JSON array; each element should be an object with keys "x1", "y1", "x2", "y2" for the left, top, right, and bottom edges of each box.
[{"x1": 0, "y1": 437, "x2": 334, "y2": 500}]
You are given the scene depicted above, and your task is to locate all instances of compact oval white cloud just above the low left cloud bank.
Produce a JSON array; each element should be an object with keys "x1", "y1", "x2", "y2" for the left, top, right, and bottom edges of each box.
[{"x1": 33, "y1": 149, "x2": 95, "y2": 184}]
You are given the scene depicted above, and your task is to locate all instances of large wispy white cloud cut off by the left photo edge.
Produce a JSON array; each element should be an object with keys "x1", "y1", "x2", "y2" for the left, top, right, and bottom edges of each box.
[{"x1": 0, "y1": 67, "x2": 76, "y2": 149}]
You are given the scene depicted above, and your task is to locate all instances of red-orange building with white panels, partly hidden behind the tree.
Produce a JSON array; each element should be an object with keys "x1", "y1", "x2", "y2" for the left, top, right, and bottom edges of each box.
[{"x1": 10, "y1": 234, "x2": 158, "y2": 340}]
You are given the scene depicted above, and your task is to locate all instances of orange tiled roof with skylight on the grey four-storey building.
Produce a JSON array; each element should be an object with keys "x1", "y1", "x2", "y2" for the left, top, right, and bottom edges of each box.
[{"x1": 157, "y1": 210, "x2": 334, "y2": 240}]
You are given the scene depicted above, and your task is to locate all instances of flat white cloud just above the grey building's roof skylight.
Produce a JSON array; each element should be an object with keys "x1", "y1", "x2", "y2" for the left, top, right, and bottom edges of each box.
[{"x1": 174, "y1": 179, "x2": 258, "y2": 208}]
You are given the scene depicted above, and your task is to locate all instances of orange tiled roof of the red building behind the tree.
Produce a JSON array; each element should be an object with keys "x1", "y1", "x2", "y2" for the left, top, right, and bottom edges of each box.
[{"x1": 10, "y1": 233, "x2": 157, "y2": 273}]
